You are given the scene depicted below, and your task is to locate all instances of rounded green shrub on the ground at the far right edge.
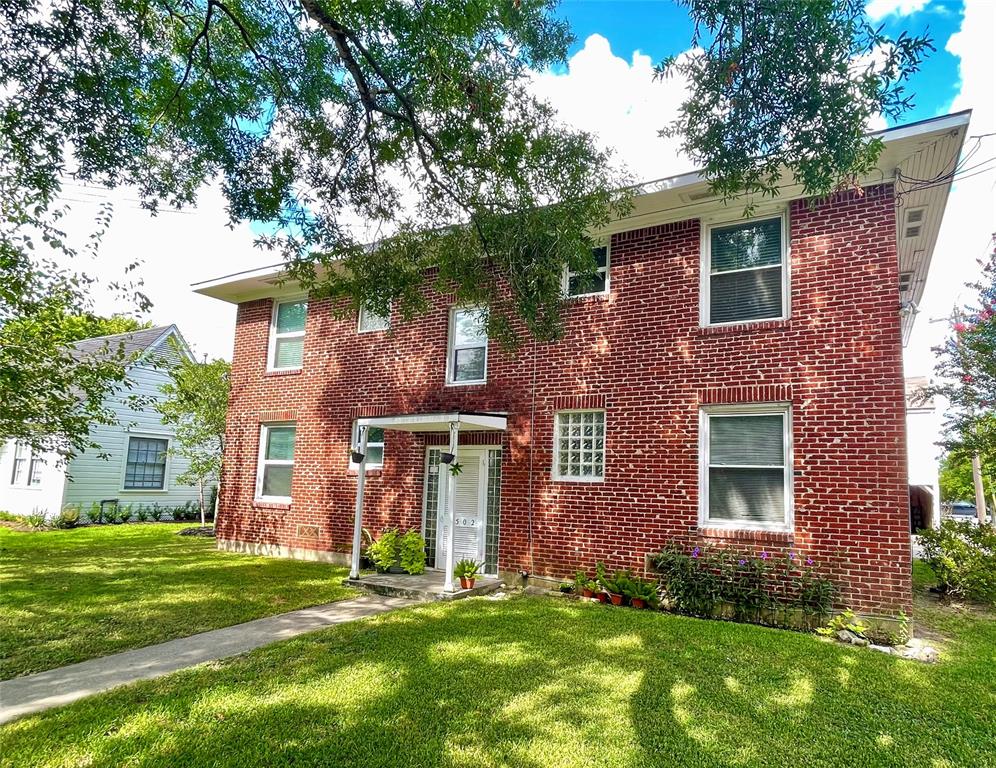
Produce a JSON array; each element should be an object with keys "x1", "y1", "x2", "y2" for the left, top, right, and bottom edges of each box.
[{"x1": 920, "y1": 520, "x2": 996, "y2": 605}]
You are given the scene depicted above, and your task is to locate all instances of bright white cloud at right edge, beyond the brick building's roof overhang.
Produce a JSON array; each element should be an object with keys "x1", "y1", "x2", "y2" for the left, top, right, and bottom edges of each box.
[{"x1": 905, "y1": 0, "x2": 996, "y2": 375}]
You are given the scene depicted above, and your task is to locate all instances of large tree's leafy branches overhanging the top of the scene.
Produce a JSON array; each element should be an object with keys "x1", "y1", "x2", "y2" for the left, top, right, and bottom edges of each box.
[{"x1": 0, "y1": 0, "x2": 928, "y2": 450}]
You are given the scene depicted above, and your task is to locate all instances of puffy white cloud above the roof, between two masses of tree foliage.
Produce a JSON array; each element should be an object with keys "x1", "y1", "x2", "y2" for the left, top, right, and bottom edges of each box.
[{"x1": 532, "y1": 35, "x2": 694, "y2": 181}]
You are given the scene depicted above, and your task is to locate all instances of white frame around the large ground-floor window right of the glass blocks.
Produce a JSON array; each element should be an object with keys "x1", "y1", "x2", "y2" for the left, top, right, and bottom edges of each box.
[{"x1": 699, "y1": 403, "x2": 795, "y2": 532}]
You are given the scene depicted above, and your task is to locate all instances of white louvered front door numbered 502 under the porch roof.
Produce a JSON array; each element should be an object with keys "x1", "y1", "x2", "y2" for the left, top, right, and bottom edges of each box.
[{"x1": 436, "y1": 448, "x2": 488, "y2": 568}]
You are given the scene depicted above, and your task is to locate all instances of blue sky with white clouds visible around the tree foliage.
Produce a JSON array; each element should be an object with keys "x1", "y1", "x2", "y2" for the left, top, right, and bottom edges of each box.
[{"x1": 56, "y1": 0, "x2": 996, "y2": 375}]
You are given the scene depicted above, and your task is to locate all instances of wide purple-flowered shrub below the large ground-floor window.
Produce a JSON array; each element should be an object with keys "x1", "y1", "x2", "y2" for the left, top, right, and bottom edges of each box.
[{"x1": 653, "y1": 543, "x2": 838, "y2": 624}]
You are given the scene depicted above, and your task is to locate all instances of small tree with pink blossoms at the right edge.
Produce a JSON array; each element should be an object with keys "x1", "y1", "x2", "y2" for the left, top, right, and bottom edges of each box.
[{"x1": 928, "y1": 238, "x2": 996, "y2": 525}]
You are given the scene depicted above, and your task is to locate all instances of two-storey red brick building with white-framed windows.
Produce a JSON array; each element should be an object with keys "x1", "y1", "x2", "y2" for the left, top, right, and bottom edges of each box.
[{"x1": 195, "y1": 113, "x2": 969, "y2": 615}]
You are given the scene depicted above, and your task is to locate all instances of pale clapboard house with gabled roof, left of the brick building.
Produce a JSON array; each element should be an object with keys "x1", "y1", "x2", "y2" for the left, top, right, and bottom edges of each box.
[{"x1": 0, "y1": 325, "x2": 197, "y2": 516}]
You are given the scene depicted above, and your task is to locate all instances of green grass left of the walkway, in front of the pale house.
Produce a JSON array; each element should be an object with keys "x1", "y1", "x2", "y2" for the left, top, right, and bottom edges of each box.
[{"x1": 0, "y1": 523, "x2": 355, "y2": 679}]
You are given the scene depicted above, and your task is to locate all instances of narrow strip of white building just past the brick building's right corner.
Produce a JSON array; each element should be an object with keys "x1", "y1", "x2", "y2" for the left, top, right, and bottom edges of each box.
[{"x1": 906, "y1": 376, "x2": 941, "y2": 531}]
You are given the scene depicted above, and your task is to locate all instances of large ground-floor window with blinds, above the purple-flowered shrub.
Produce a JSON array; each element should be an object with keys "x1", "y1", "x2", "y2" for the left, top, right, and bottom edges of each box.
[{"x1": 701, "y1": 405, "x2": 792, "y2": 530}]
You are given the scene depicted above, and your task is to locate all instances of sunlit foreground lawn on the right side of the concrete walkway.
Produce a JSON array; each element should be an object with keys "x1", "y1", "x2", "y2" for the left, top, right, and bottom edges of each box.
[{"x1": 0, "y1": 560, "x2": 996, "y2": 768}]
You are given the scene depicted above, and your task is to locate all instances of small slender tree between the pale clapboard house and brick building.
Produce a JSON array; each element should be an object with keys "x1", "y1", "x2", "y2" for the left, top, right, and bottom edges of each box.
[{"x1": 155, "y1": 348, "x2": 231, "y2": 528}]
